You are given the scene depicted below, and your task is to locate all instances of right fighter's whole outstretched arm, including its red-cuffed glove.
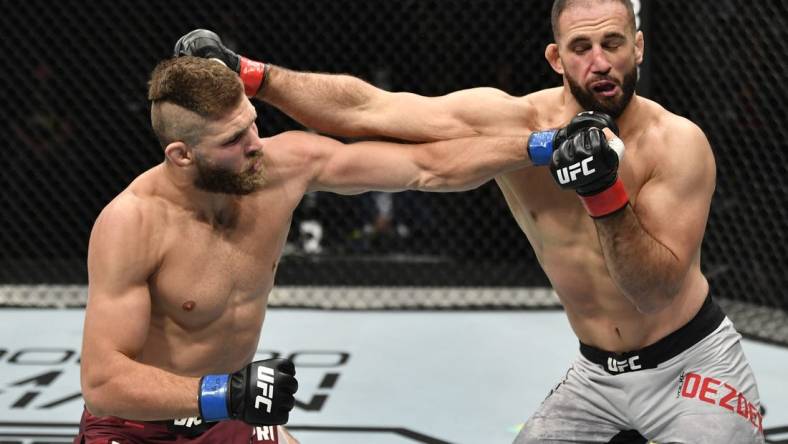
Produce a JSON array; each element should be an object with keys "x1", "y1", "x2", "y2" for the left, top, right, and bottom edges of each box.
[{"x1": 175, "y1": 30, "x2": 536, "y2": 142}]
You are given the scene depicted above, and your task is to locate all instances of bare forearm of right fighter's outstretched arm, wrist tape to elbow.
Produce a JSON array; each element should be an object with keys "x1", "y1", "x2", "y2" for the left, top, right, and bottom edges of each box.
[{"x1": 257, "y1": 66, "x2": 386, "y2": 137}]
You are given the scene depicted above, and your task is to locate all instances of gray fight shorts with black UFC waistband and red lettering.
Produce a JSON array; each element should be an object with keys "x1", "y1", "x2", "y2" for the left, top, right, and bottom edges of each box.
[{"x1": 515, "y1": 298, "x2": 764, "y2": 444}]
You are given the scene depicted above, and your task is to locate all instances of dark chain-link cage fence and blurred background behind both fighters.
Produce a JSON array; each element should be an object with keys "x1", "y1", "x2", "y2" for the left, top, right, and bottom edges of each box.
[{"x1": 0, "y1": 0, "x2": 788, "y2": 343}]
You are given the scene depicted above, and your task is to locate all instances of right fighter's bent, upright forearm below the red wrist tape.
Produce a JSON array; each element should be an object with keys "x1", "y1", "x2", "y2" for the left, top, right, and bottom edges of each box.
[{"x1": 595, "y1": 206, "x2": 686, "y2": 313}]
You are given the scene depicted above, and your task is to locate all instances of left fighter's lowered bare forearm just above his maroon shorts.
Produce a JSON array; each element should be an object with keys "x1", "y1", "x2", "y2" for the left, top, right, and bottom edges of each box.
[{"x1": 82, "y1": 354, "x2": 200, "y2": 421}]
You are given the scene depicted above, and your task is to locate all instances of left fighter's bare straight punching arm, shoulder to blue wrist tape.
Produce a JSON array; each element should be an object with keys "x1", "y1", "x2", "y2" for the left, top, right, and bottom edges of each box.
[{"x1": 279, "y1": 131, "x2": 531, "y2": 194}]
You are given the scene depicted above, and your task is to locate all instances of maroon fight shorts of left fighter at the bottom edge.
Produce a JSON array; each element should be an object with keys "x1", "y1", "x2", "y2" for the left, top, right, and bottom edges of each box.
[{"x1": 74, "y1": 409, "x2": 287, "y2": 444}]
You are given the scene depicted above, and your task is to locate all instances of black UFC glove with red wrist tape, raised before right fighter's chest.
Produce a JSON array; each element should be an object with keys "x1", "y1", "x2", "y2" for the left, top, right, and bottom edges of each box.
[{"x1": 550, "y1": 127, "x2": 629, "y2": 218}]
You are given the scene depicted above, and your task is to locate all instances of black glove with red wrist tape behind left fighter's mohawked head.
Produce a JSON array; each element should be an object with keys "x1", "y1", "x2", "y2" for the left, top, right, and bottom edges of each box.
[{"x1": 174, "y1": 29, "x2": 268, "y2": 97}]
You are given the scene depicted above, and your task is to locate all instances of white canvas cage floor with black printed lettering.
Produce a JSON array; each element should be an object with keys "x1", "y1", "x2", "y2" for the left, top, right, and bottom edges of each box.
[{"x1": 0, "y1": 309, "x2": 788, "y2": 444}]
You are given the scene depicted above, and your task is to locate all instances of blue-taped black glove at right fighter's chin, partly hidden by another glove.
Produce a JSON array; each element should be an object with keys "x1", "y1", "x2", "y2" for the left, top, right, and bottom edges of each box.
[{"x1": 528, "y1": 111, "x2": 618, "y2": 166}]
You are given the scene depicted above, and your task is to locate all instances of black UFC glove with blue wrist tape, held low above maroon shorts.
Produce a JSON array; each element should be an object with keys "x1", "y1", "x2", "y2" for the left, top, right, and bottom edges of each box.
[{"x1": 198, "y1": 359, "x2": 298, "y2": 425}]
